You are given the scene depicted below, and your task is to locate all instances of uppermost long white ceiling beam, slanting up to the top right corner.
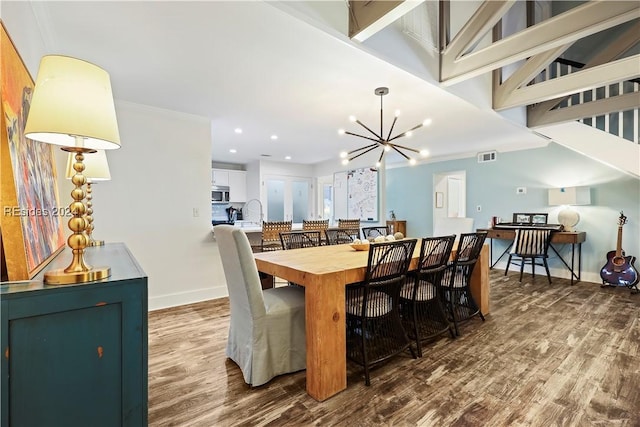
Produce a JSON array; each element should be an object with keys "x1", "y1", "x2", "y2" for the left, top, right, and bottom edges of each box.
[{"x1": 440, "y1": 1, "x2": 640, "y2": 85}]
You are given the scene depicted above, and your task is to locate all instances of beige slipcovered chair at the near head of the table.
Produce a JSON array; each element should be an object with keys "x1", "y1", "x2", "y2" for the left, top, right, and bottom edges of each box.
[{"x1": 213, "y1": 225, "x2": 307, "y2": 387}]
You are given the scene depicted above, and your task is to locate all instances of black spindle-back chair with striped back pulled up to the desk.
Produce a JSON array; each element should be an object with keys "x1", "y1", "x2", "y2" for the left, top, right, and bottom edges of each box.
[{"x1": 504, "y1": 228, "x2": 551, "y2": 284}]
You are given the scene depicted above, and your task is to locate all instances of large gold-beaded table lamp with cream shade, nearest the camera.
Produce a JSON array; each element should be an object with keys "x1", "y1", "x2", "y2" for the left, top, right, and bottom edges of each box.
[{"x1": 24, "y1": 55, "x2": 120, "y2": 285}]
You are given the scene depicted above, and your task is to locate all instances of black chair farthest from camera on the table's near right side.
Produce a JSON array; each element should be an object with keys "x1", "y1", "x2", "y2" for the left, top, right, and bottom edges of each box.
[{"x1": 441, "y1": 232, "x2": 487, "y2": 335}]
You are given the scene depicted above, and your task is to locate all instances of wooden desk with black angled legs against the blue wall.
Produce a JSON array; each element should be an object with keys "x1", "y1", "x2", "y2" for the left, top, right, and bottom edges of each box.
[{"x1": 478, "y1": 228, "x2": 587, "y2": 285}]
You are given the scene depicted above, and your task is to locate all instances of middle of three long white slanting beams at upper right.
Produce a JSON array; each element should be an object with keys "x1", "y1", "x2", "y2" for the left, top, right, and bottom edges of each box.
[{"x1": 501, "y1": 54, "x2": 640, "y2": 109}]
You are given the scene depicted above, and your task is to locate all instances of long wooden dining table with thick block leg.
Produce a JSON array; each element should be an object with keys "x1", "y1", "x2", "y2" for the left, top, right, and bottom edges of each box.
[{"x1": 254, "y1": 239, "x2": 489, "y2": 401}]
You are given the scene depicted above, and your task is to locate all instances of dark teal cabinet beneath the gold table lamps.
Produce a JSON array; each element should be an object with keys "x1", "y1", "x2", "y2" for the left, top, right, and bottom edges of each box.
[{"x1": 0, "y1": 243, "x2": 148, "y2": 427}]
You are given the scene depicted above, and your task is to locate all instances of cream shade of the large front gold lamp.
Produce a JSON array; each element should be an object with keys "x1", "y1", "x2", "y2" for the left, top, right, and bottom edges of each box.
[{"x1": 24, "y1": 55, "x2": 120, "y2": 150}]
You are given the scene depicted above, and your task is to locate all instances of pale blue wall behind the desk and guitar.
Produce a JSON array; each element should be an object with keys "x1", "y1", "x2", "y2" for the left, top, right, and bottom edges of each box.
[{"x1": 386, "y1": 143, "x2": 640, "y2": 282}]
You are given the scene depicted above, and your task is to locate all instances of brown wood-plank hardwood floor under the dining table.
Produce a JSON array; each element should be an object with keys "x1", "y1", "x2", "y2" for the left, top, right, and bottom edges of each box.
[{"x1": 149, "y1": 270, "x2": 640, "y2": 427}]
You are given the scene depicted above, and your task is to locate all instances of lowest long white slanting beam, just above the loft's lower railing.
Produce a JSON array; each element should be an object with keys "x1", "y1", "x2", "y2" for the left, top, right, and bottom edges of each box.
[{"x1": 527, "y1": 92, "x2": 640, "y2": 129}]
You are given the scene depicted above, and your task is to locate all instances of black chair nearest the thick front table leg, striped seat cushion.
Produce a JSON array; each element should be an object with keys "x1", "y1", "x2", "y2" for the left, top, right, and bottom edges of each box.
[{"x1": 346, "y1": 239, "x2": 416, "y2": 385}]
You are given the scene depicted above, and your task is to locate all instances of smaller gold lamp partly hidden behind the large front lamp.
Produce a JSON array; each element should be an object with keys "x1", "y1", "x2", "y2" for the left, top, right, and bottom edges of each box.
[{"x1": 66, "y1": 150, "x2": 111, "y2": 246}]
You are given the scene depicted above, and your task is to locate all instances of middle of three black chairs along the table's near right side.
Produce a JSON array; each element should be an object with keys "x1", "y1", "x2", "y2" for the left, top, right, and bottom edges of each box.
[{"x1": 400, "y1": 234, "x2": 456, "y2": 357}]
